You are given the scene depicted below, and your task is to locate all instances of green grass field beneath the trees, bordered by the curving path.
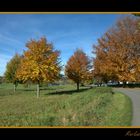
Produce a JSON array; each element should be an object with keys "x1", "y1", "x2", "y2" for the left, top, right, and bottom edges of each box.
[{"x1": 0, "y1": 84, "x2": 132, "y2": 126}]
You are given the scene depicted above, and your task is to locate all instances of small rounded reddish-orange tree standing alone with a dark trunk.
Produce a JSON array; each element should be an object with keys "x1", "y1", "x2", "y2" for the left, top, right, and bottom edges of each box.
[{"x1": 65, "y1": 49, "x2": 91, "y2": 90}]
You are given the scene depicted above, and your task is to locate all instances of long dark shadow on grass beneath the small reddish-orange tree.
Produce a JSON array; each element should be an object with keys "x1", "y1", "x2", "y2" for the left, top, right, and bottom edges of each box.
[{"x1": 45, "y1": 88, "x2": 91, "y2": 95}]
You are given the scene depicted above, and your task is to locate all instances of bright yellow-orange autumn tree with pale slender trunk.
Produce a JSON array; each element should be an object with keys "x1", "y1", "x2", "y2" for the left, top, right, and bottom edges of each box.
[{"x1": 17, "y1": 37, "x2": 61, "y2": 97}]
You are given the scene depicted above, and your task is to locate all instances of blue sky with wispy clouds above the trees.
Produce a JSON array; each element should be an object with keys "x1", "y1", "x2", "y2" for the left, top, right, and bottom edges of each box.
[{"x1": 0, "y1": 14, "x2": 130, "y2": 75}]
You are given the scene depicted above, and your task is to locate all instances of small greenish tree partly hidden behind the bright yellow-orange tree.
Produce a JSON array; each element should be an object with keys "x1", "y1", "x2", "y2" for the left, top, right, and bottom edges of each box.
[{"x1": 4, "y1": 54, "x2": 21, "y2": 92}]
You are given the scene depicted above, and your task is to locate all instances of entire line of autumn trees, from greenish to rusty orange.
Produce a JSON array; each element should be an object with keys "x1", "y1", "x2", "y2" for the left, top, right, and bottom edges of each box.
[{"x1": 4, "y1": 16, "x2": 140, "y2": 97}]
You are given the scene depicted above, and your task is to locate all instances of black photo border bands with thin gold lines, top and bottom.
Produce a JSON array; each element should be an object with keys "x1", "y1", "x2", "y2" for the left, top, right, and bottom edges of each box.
[{"x1": 0, "y1": 0, "x2": 140, "y2": 139}]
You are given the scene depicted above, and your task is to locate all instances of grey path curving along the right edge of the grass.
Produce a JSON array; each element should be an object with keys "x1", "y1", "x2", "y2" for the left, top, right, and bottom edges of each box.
[{"x1": 114, "y1": 88, "x2": 140, "y2": 126}]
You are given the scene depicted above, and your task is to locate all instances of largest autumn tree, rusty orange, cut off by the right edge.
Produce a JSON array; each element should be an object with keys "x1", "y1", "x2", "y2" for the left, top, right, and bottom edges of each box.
[{"x1": 94, "y1": 16, "x2": 140, "y2": 87}]
